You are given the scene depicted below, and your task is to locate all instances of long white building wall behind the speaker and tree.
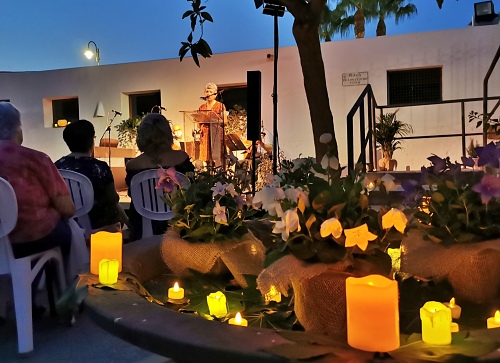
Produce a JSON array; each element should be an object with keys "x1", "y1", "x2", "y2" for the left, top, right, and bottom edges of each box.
[{"x1": 0, "y1": 25, "x2": 500, "y2": 169}]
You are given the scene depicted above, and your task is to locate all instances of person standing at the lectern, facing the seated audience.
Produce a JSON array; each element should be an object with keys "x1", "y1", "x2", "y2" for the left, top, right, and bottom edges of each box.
[{"x1": 198, "y1": 83, "x2": 226, "y2": 166}]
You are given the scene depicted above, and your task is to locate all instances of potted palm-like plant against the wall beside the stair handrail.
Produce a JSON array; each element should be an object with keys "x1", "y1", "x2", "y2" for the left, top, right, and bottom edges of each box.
[{"x1": 375, "y1": 109, "x2": 413, "y2": 171}]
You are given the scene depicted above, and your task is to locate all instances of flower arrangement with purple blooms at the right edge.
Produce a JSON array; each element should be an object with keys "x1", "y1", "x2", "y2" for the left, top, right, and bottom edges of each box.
[{"x1": 403, "y1": 143, "x2": 500, "y2": 245}]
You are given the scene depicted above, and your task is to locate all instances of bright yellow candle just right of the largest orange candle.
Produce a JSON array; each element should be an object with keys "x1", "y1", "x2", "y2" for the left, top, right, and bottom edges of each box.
[{"x1": 420, "y1": 301, "x2": 451, "y2": 345}]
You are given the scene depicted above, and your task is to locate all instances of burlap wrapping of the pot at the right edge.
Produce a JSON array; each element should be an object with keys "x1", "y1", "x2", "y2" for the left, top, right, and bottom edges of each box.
[{"x1": 401, "y1": 231, "x2": 500, "y2": 304}]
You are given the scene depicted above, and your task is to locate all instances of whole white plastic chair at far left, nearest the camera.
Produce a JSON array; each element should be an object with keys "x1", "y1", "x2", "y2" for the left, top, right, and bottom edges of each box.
[{"x1": 0, "y1": 178, "x2": 66, "y2": 353}]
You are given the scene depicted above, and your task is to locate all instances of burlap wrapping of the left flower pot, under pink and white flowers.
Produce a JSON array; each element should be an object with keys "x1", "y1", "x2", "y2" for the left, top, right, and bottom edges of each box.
[{"x1": 160, "y1": 228, "x2": 266, "y2": 287}]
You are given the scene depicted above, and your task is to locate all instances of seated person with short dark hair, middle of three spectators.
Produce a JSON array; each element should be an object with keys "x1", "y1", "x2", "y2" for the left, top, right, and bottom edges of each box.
[{"x1": 55, "y1": 120, "x2": 128, "y2": 232}]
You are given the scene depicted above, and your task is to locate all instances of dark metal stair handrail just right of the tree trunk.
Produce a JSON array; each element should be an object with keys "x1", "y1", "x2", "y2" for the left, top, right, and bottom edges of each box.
[{"x1": 347, "y1": 84, "x2": 377, "y2": 171}]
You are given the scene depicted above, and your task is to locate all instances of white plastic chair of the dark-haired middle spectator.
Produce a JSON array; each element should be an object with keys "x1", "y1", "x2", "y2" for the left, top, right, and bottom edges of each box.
[{"x1": 59, "y1": 169, "x2": 94, "y2": 238}]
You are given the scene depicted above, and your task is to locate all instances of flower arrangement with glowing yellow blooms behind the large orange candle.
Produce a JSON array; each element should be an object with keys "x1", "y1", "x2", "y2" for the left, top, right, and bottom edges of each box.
[{"x1": 253, "y1": 134, "x2": 407, "y2": 264}]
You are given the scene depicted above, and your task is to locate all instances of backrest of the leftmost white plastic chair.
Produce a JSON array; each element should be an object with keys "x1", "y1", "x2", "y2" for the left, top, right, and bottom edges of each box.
[{"x1": 0, "y1": 178, "x2": 18, "y2": 275}]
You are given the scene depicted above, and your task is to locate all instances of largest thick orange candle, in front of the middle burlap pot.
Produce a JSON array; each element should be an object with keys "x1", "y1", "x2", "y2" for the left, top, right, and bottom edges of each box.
[{"x1": 346, "y1": 275, "x2": 399, "y2": 352}]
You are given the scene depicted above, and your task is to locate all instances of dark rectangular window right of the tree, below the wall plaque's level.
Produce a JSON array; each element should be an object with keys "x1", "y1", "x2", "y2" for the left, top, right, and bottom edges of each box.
[{"x1": 387, "y1": 67, "x2": 443, "y2": 105}]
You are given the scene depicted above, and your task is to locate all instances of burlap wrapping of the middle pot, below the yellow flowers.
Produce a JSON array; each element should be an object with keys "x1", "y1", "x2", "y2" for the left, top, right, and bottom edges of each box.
[{"x1": 257, "y1": 255, "x2": 354, "y2": 334}]
